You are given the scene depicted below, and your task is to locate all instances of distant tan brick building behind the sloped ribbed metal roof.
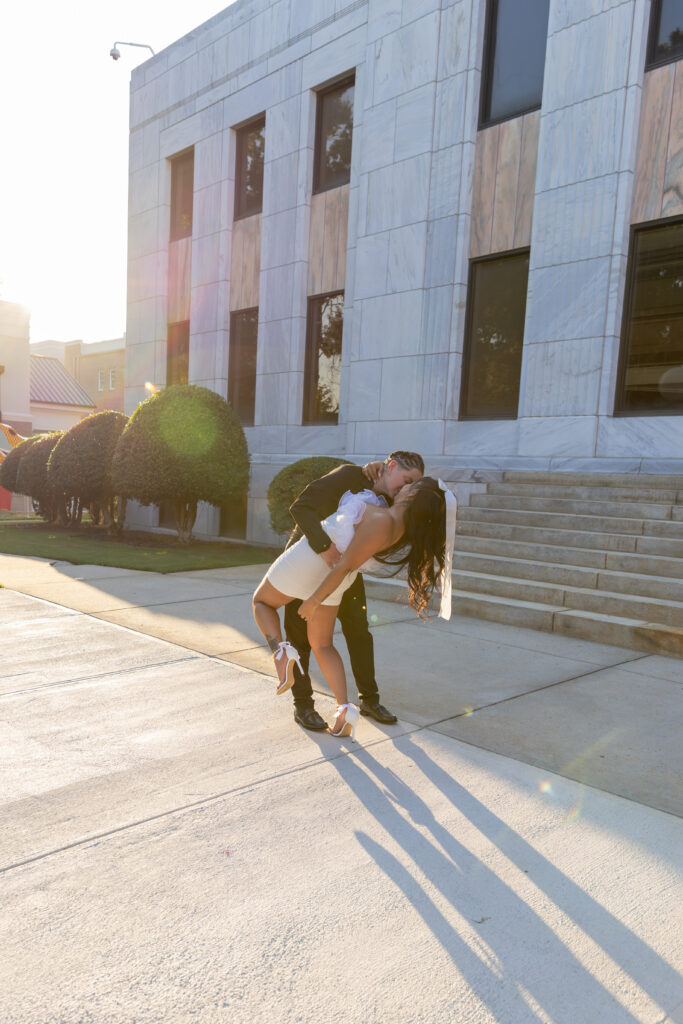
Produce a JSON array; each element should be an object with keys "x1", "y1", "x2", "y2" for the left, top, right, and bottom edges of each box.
[{"x1": 31, "y1": 338, "x2": 126, "y2": 413}]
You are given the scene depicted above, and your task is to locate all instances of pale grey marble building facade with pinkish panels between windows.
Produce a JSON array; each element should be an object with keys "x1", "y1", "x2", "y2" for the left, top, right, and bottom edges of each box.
[{"x1": 125, "y1": 0, "x2": 683, "y2": 540}]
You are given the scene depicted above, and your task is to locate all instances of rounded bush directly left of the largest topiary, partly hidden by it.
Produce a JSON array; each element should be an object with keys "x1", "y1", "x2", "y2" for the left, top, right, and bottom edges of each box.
[{"x1": 48, "y1": 411, "x2": 128, "y2": 528}]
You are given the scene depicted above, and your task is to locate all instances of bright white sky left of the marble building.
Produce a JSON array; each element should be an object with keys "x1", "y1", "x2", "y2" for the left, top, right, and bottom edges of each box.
[{"x1": 0, "y1": 0, "x2": 233, "y2": 341}]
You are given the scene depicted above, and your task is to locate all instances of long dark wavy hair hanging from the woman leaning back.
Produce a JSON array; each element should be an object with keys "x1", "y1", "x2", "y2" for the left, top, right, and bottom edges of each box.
[{"x1": 375, "y1": 476, "x2": 445, "y2": 618}]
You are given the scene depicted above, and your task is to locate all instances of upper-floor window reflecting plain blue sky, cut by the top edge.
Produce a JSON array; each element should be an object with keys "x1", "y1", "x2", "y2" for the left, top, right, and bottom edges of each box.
[{"x1": 479, "y1": 0, "x2": 550, "y2": 127}]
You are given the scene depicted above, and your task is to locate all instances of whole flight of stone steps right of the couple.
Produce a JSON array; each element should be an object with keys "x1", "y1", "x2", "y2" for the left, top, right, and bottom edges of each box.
[{"x1": 369, "y1": 471, "x2": 683, "y2": 657}]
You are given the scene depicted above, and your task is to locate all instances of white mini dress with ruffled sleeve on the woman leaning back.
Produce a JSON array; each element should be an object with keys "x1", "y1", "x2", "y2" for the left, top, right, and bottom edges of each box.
[{"x1": 264, "y1": 489, "x2": 387, "y2": 605}]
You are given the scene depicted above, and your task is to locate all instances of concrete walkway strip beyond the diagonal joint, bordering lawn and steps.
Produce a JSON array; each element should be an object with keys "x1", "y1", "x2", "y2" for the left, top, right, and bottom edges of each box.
[{"x1": 0, "y1": 555, "x2": 683, "y2": 816}]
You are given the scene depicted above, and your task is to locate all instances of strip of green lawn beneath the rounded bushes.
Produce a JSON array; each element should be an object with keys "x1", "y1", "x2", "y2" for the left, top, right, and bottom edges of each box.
[{"x1": 0, "y1": 521, "x2": 281, "y2": 572}]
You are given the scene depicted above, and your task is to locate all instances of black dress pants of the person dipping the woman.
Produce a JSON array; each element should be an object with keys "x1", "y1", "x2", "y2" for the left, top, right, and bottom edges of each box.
[{"x1": 285, "y1": 572, "x2": 378, "y2": 709}]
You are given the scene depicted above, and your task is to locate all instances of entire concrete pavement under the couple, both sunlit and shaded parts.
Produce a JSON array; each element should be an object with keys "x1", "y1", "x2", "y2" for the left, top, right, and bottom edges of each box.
[{"x1": 0, "y1": 556, "x2": 683, "y2": 1024}]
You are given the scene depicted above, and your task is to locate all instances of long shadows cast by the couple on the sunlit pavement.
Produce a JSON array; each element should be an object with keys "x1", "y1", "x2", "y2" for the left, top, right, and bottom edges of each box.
[{"x1": 330, "y1": 736, "x2": 680, "y2": 1024}]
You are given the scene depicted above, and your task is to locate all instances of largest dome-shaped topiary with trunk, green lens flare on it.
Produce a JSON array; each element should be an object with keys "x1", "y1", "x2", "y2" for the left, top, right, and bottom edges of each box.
[{"x1": 112, "y1": 384, "x2": 249, "y2": 543}]
